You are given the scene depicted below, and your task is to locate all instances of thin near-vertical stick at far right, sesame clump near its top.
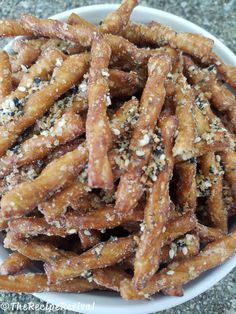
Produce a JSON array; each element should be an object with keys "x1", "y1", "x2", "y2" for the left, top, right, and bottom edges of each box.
[{"x1": 200, "y1": 153, "x2": 228, "y2": 232}]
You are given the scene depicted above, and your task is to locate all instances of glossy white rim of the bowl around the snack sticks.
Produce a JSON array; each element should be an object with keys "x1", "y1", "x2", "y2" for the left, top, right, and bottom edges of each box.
[{"x1": 0, "y1": 4, "x2": 236, "y2": 314}]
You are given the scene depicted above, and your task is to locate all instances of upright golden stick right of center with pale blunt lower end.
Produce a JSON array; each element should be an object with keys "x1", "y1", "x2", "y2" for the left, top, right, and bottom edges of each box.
[{"x1": 173, "y1": 74, "x2": 195, "y2": 160}]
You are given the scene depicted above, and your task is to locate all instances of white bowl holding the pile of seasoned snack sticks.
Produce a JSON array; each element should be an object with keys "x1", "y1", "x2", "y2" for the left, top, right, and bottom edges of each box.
[{"x1": 0, "y1": 4, "x2": 236, "y2": 314}]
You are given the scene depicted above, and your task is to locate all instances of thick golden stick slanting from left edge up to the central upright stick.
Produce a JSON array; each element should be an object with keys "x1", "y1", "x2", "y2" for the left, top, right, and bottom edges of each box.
[{"x1": 0, "y1": 54, "x2": 88, "y2": 155}]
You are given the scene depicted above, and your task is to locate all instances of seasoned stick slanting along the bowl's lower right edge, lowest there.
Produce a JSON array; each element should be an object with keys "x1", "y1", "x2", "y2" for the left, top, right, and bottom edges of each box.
[{"x1": 120, "y1": 232, "x2": 236, "y2": 299}]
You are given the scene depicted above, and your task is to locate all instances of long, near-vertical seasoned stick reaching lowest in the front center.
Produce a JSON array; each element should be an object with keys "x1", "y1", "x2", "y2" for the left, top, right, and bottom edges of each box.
[{"x1": 134, "y1": 116, "x2": 177, "y2": 289}]
